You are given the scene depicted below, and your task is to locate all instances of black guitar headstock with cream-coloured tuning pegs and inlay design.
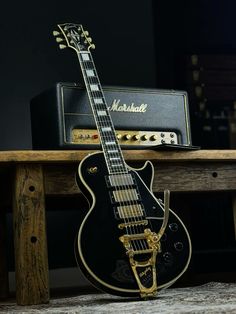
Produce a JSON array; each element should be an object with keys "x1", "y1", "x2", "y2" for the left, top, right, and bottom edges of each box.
[{"x1": 53, "y1": 23, "x2": 95, "y2": 52}]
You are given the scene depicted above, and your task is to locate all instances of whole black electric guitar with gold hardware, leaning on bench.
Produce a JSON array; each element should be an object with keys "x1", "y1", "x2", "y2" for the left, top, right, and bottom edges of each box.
[{"x1": 54, "y1": 23, "x2": 191, "y2": 298}]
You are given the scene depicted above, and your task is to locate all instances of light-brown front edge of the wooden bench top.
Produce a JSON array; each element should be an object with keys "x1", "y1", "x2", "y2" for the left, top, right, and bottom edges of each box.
[{"x1": 0, "y1": 150, "x2": 236, "y2": 165}]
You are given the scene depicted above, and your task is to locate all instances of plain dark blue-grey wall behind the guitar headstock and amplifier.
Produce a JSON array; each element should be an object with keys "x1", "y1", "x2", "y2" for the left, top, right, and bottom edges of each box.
[{"x1": 0, "y1": 0, "x2": 155, "y2": 149}]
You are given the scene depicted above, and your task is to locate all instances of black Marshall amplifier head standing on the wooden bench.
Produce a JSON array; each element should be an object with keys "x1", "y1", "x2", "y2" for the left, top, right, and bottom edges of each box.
[{"x1": 30, "y1": 83, "x2": 191, "y2": 149}]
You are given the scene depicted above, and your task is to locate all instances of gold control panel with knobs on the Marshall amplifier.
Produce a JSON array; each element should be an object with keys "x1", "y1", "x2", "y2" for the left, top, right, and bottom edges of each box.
[{"x1": 71, "y1": 129, "x2": 178, "y2": 146}]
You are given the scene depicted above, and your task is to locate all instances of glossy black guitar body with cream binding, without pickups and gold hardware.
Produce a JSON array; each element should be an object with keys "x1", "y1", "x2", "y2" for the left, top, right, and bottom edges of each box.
[{"x1": 75, "y1": 153, "x2": 191, "y2": 297}]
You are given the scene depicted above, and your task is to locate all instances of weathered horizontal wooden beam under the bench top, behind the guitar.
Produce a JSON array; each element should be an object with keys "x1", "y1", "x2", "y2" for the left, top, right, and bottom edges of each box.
[{"x1": 44, "y1": 162, "x2": 236, "y2": 195}]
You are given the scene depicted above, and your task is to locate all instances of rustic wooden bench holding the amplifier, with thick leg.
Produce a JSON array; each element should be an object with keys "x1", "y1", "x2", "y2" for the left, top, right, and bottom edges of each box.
[{"x1": 0, "y1": 150, "x2": 236, "y2": 305}]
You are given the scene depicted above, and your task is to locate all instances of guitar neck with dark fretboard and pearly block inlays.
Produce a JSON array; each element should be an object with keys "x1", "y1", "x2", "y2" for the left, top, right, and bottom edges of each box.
[{"x1": 78, "y1": 51, "x2": 127, "y2": 174}]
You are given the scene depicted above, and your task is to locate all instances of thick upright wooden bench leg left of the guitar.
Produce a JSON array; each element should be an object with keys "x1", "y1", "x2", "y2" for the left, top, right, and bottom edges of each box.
[{"x1": 13, "y1": 164, "x2": 49, "y2": 305}]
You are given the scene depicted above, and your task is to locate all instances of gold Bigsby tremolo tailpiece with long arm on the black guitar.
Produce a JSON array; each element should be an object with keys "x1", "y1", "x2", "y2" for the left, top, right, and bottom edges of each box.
[{"x1": 119, "y1": 190, "x2": 170, "y2": 298}]
